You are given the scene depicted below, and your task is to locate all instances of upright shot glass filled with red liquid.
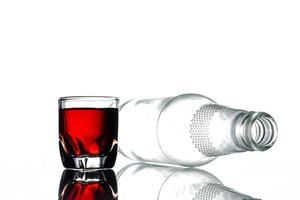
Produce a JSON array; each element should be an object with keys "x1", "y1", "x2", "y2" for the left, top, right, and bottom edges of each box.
[{"x1": 59, "y1": 96, "x2": 119, "y2": 169}]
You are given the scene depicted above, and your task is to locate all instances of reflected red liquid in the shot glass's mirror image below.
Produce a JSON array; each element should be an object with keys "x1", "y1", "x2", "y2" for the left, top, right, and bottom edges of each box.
[{"x1": 62, "y1": 182, "x2": 117, "y2": 200}]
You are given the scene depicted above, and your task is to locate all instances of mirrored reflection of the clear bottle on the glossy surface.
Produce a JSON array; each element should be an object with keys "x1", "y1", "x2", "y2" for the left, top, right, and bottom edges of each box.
[{"x1": 117, "y1": 164, "x2": 257, "y2": 200}]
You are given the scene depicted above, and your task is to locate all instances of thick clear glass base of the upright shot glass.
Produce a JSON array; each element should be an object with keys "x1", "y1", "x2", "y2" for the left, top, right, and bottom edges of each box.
[{"x1": 59, "y1": 143, "x2": 118, "y2": 169}]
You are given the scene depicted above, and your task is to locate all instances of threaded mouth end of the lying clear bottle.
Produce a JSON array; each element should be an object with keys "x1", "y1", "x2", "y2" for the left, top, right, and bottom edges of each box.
[{"x1": 235, "y1": 112, "x2": 277, "y2": 151}]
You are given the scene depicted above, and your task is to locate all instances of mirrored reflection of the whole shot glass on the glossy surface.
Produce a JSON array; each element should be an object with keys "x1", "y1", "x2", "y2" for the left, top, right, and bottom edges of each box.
[{"x1": 59, "y1": 170, "x2": 118, "y2": 200}]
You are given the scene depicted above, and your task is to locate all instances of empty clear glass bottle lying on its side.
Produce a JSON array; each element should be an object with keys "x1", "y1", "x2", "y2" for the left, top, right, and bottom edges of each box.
[{"x1": 119, "y1": 94, "x2": 277, "y2": 166}]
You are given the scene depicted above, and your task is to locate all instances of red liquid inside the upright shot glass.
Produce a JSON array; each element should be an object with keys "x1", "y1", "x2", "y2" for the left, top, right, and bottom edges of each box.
[{"x1": 59, "y1": 108, "x2": 118, "y2": 157}]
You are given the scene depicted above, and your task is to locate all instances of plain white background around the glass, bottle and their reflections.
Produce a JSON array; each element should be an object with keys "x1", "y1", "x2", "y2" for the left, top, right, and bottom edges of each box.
[{"x1": 0, "y1": 0, "x2": 300, "y2": 200}]
